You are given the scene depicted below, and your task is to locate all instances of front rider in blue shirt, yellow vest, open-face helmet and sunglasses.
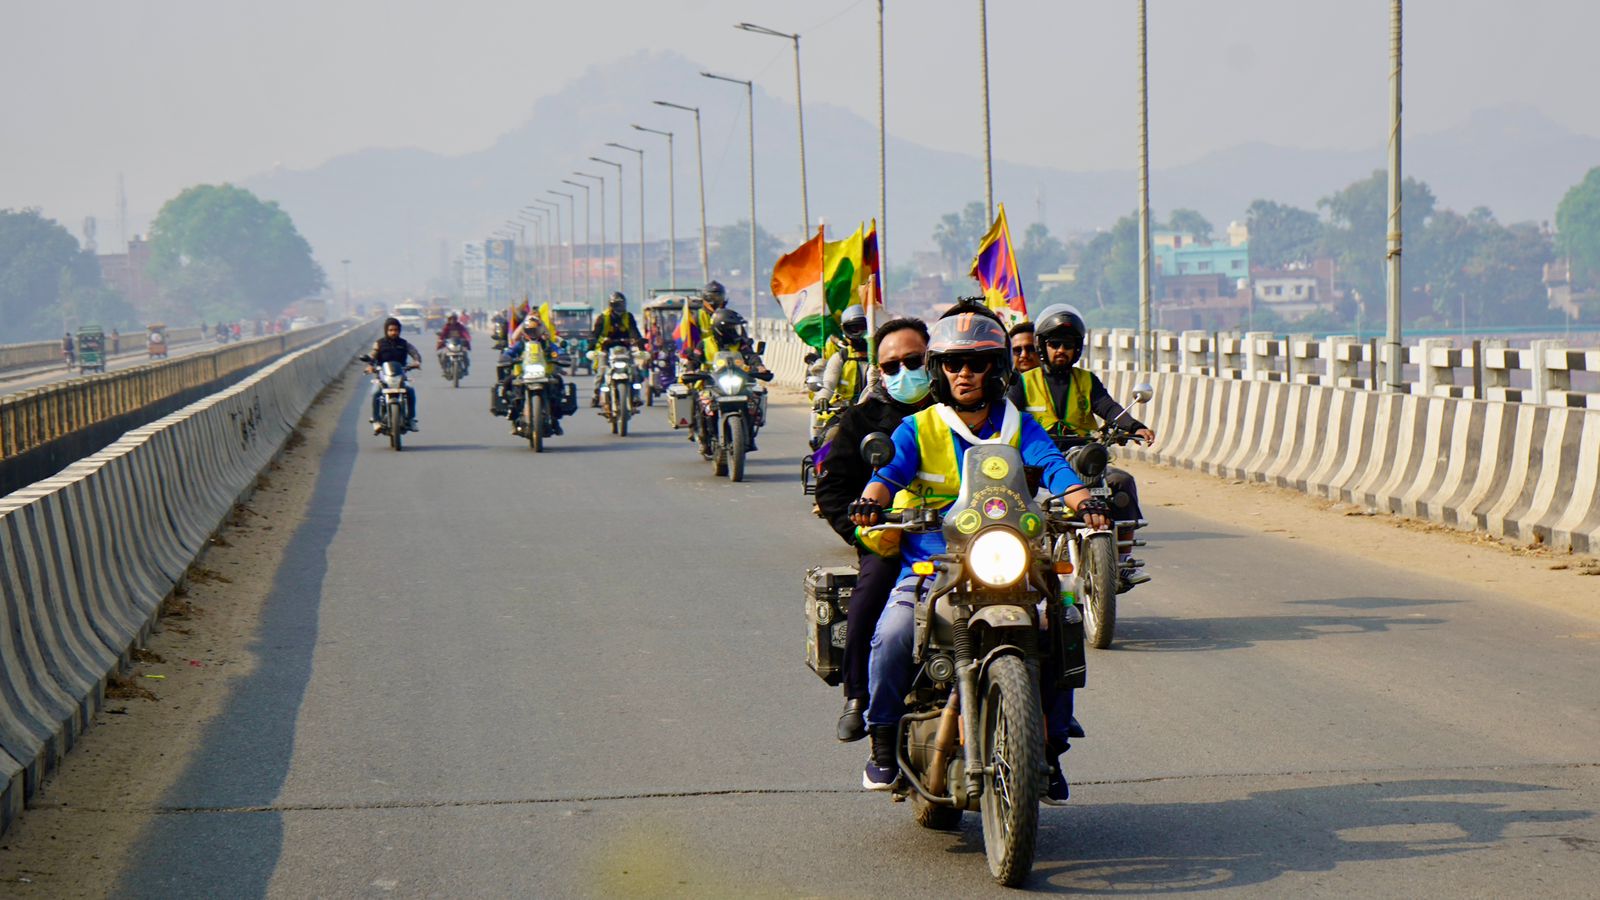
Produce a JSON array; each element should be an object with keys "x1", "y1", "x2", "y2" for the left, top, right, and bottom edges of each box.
[{"x1": 850, "y1": 303, "x2": 1110, "y2": 804}]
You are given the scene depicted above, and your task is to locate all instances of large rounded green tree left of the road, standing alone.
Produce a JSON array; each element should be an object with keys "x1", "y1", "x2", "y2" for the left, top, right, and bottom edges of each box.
[{"x1": 150, "y1": 184, "x2": 328, "y2": 319}]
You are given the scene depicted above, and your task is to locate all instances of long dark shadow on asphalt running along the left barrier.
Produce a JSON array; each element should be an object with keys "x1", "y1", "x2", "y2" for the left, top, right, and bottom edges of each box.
[{"x1": 115, "y1": 381, "x2": 366, "y2": 897}]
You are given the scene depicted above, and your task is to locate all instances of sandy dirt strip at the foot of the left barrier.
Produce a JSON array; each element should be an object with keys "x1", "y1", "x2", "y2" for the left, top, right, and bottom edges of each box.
[{"x1": 0, "y1": 368, "x2": 358, "y2": 897}]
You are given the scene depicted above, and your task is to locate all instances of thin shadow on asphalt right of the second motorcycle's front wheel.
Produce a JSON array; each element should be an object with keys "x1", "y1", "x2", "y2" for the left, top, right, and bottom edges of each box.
[{"x1": 1114, "y1": 597, "x2": 1446, "y2": 653}]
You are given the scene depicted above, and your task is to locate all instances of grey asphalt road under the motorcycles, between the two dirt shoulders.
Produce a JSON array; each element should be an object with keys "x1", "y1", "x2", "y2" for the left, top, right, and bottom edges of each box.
[{"x1": 118, "y1": 351, "x2": 1600, "y2": 897}]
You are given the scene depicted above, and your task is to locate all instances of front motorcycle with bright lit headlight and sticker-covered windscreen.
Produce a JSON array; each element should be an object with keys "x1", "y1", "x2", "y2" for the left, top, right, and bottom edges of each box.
[{"x1": 808, "y1": 432, "x2": 1086, "y2": 887}]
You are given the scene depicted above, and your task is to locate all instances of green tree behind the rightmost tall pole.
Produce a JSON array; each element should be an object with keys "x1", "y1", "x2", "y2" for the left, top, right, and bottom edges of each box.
[{"x1": 1317, "y1": 170, "x2": 1435, "y2": 317}]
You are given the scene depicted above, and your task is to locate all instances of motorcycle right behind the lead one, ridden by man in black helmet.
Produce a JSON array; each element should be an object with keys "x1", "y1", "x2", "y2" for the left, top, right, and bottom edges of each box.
[{"x1": 1045, "y1": 377, "x2": 1155, "y2": 650}]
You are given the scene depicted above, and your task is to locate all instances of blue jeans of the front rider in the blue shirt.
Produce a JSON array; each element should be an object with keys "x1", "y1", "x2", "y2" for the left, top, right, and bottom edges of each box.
[{"x1": 867, "y1": 575, "x2": 1072, "y2": 749}]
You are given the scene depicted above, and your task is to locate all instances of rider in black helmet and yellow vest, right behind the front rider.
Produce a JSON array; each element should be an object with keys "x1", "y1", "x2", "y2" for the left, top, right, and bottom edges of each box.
[{"x1": 1011, "y1": 303, "x2": 1155, "y2": 576}]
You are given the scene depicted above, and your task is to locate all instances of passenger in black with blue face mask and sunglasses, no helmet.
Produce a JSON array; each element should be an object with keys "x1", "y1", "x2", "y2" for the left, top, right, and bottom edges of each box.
[{"x1": 816, "y1": 319, "x2": 931, "y2": 741}]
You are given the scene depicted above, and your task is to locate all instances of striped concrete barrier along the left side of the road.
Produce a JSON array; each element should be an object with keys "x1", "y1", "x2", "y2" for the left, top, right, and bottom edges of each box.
[{"x1": 0, "y1": 323, "x2": 376, "y2": 831}]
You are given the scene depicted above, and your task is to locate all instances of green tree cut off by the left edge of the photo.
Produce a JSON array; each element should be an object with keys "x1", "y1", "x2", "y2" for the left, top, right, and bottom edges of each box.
[{"x1": 0, "y1": 210, "x2": 136, "y2": 343}]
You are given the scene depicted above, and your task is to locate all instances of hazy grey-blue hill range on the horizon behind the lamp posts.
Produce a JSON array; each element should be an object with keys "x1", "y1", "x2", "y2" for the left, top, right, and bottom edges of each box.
[{"x1": 245, "y1": 53, "x2": 1600, "y2": 287}]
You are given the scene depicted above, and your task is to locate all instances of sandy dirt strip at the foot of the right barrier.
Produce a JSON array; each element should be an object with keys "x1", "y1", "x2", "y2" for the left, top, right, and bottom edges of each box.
[{"x1": 1117, "y1": 460, "x2": 1600, "y2": 618}]
